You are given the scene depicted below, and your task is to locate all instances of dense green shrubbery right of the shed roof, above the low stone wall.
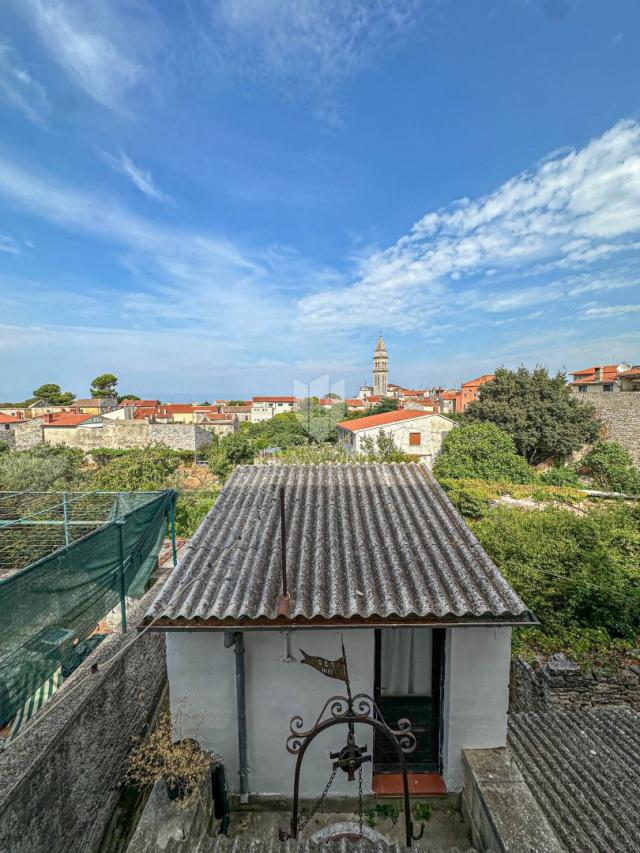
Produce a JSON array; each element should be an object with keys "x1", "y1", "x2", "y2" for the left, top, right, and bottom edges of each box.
[{"x1": 468, "y1": 503, "x2": 640, "y2": 664}]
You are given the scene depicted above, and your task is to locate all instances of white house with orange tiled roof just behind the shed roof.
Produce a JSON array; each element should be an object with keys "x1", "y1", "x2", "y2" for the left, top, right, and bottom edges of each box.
[{"x1": 336, "y1": 409, "x2": 456, "y2": 466}]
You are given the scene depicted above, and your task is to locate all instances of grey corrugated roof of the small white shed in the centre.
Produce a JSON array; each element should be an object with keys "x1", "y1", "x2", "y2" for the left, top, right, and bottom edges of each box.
[{"x1": 145, "y1": 463, "x2": 533, "y2": 626}]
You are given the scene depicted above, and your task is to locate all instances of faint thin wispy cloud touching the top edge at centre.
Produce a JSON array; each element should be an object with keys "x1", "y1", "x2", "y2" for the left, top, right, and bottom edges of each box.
[{"x1": 191, "y1": 0, "x2": 424, "y2": 118}]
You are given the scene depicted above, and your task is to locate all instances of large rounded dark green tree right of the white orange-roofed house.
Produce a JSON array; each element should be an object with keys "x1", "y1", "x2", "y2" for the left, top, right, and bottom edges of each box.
[{"x1": 465, "y1": 367, "x2": 599, "y2": 465}]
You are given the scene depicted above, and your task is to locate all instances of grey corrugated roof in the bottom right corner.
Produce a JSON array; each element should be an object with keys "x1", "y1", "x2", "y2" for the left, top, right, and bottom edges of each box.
[{"x1": 508, "y1": 708, "x2": 640, "y2": 853}]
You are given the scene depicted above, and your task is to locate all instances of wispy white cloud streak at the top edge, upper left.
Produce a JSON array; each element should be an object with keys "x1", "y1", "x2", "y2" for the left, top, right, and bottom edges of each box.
[{"x1": 24, "y1": 0, "x2": 161, "y2": 111}]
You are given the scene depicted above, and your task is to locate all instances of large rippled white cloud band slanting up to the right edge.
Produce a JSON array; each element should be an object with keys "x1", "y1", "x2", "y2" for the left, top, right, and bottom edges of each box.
[{"x1": 299, "y1": 121, "x2": 640, "y2": 331}]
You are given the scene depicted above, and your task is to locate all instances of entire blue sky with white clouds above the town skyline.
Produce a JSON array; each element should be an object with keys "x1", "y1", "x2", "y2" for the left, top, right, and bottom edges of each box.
[{"x1": 0, "y1": 0, "x2": 640, "y2": 400}]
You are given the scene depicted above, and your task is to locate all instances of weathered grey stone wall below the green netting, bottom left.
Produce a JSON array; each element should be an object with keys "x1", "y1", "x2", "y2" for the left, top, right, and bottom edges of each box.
[{"x1": 0, "y1": 588, "x2": 167, "y2": 853}]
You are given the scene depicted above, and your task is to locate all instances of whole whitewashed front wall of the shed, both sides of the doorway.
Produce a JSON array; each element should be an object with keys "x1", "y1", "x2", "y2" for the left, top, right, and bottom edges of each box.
[{"x1": 167, "y1": 627, "x2": 511, "y2": 797}]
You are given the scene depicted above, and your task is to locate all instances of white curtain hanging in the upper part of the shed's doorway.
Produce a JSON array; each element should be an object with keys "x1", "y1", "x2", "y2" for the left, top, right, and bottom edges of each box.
[{"x1": 380, "y1": 628, "x2": 433, "y2": 696}]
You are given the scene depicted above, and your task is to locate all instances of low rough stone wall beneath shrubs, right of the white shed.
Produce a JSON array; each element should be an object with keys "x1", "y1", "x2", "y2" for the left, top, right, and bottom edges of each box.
[{"x1": 509, "y1": 654, "x2": 640, "y2": 713}]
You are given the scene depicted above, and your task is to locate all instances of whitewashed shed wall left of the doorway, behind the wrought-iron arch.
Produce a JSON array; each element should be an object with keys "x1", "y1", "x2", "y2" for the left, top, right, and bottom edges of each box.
[{"x1": 167, "y1": 629, "x2": 374, "y2": 797}]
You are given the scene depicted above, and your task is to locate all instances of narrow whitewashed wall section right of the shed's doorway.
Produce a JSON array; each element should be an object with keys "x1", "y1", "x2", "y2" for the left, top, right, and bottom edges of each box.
[{"x1": 442, "y1": 628, "x2": 511, "y2": 791}]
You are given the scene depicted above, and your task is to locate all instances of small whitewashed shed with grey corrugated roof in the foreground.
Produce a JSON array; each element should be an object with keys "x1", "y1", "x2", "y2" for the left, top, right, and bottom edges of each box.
[{"x1": 146, "y1": 464, "x2": 535, "y2": 802}]
